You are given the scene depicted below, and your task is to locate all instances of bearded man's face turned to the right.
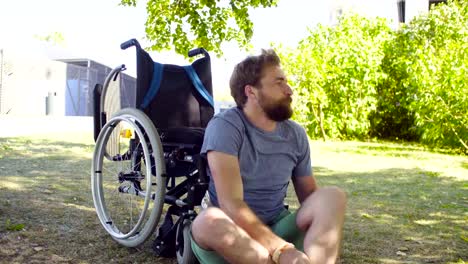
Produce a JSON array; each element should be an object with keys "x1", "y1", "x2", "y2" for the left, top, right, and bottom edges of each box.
[{"x1": 258, "y1": 66, "x2": 293, "y2": 122}]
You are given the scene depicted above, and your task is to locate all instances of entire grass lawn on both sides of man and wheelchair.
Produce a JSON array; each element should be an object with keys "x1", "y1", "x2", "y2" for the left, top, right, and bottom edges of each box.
[{"x1": 0, "y1": 134, "x2": 468, "y2": 263}]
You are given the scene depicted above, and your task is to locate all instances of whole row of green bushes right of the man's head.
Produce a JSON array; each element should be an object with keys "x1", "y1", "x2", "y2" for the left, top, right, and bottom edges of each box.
[{"x1": 279, "y1": 1, "x2": 468, "y2": 151}]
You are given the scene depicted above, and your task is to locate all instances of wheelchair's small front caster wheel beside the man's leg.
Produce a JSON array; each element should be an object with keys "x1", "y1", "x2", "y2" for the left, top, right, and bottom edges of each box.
[{"x1": 176, "y1": 220, "x2": 198, "y2": 264}]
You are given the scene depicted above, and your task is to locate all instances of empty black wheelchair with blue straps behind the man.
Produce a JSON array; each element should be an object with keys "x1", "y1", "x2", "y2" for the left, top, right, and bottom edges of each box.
[{"x1": 91, "y1": 39, "x2": 214, "y2": 263}]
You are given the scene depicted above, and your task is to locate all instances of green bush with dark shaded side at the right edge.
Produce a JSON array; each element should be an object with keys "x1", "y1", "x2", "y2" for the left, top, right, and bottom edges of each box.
[{"x1": 376, "y1": 2, "x2": 468, "y2": 150}]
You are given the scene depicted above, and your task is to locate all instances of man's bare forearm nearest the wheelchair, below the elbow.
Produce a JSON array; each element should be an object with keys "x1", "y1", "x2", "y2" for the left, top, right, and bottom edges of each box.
[{"x1": 221, "y1": 201, "x2": 286, "y2": 254}]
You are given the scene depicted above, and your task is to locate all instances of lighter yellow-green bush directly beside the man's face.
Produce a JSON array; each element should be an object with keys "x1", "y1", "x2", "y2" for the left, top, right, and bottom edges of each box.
[{"x1": 279, "y1": 14, "x2": 391, "y2": 139}]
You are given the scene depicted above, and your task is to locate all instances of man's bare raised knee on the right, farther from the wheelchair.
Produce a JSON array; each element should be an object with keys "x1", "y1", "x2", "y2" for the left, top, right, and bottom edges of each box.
[{"x1": 296, "y1": 186, "x2": 347, "y2": 230}]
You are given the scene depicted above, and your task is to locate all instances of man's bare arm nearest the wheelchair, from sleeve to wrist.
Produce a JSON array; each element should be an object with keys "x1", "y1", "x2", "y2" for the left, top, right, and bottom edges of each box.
[{"x1": 208, "y1": 151, "x2": 287, "y2": 254}]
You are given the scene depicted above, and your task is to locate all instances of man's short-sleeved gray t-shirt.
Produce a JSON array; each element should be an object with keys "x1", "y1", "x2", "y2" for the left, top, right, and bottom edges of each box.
[{"x1": 201, "y1": 107, "x2": 312, "y2": 224}]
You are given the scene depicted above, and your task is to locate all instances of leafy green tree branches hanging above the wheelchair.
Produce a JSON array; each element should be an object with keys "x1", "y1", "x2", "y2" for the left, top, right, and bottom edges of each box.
[{"x1": 121, "y1": 0, "x2": 276, "y2": 56}]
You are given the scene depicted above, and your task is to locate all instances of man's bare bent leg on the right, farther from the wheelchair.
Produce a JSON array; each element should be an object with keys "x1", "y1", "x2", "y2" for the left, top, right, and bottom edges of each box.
[{"x1": 296, "y1": 187, "x2": 346, "y2": 264}]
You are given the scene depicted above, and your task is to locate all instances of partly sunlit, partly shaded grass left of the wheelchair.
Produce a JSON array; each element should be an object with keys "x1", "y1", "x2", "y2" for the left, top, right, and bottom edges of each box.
[{"x1": 0, "y1": 135, "x2": 175, "y2": 263}]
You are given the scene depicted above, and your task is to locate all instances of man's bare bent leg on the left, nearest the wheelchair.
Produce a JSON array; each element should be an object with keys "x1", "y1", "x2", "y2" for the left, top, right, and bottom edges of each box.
[{"x1": 192, "y1": 207, "x2": 269, "y2": 263}]
